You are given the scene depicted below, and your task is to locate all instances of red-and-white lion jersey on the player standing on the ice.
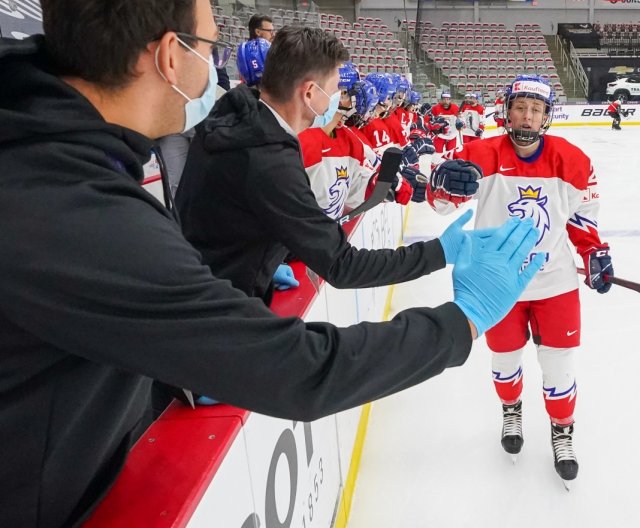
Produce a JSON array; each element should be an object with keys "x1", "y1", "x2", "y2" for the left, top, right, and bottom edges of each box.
[{"x1": 432, "y1": 135, "x2": 602, "y2": 301}]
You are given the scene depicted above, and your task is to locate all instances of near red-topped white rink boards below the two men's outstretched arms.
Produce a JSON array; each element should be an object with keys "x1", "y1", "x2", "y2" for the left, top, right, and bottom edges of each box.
[{"x1": 85, "y1": 198, "x2": 405, "y2": 528}]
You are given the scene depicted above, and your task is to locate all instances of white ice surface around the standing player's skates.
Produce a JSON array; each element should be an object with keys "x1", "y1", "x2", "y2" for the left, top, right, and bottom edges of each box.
[{"x1": 348, "y1": 128, "x2": 640, "y2": 528}]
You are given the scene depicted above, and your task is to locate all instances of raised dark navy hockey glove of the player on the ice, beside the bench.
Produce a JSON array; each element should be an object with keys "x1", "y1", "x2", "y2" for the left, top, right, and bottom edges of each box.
[{"x1": 430, "y1": 159, "x2": 482, "y2": 202}]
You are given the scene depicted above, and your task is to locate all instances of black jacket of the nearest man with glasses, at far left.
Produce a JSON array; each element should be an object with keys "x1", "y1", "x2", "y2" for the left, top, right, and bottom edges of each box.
[{"x1": 0, "y1": 38, "x2": 471, "y2": 528}]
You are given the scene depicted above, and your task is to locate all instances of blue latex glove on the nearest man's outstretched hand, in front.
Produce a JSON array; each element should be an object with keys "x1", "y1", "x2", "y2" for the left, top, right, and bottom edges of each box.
[{"x1": 453, "y1": 218, "x2": 545, "y2": 336}]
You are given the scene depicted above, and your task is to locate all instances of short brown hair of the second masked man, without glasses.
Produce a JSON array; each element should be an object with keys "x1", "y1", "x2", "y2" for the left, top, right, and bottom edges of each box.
[{"x1": 260, "y1": 26, "x2": 349, "y2": 103}]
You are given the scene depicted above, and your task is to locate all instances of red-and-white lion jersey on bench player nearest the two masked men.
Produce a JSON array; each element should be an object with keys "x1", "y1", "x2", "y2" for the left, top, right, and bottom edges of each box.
[{"x1": 298, "y1": 127, "x2": 380, "y2": 219}]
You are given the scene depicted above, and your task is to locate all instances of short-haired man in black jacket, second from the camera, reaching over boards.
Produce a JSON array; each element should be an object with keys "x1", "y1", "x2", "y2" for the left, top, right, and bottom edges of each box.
[{"x1": 176, "y1": 27, "x2": 476, "y2": 304}]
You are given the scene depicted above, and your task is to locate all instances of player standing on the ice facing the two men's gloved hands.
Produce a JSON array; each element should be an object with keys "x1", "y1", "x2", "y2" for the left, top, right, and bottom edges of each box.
[{"x1": 429, "y1": 75, "x2": 613, "y2": 486}]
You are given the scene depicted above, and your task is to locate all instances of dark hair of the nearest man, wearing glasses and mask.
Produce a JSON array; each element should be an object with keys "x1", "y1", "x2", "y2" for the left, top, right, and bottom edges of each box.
[{"x1": 41, "y1": 0, "x2": 196, "y2": 88}]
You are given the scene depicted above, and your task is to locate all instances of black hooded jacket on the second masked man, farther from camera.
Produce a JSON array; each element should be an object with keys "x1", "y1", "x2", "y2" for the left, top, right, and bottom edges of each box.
[{"x1": 176, "y1": 85, "x2": 445, "y2": 304}]
